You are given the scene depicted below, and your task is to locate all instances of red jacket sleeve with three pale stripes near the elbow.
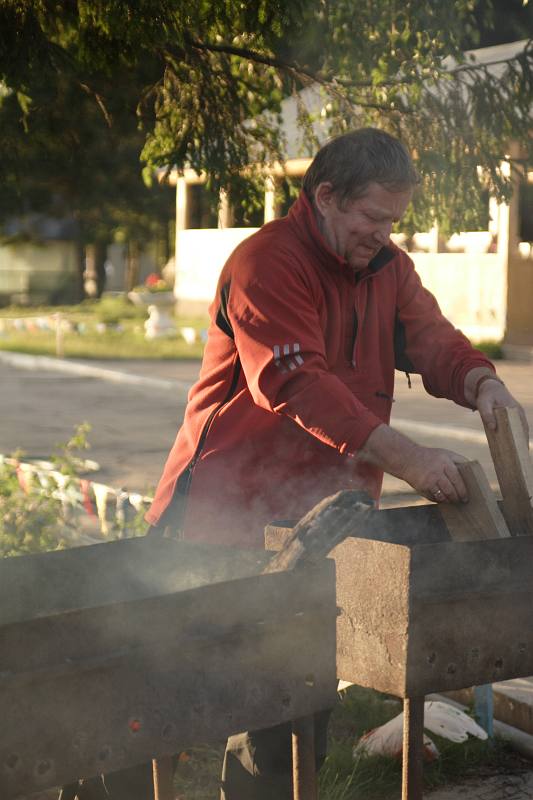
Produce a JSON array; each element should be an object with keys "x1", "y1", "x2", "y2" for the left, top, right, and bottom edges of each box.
[{"x1": 228, "y1": 247, "x2": 382, "y2": 455}]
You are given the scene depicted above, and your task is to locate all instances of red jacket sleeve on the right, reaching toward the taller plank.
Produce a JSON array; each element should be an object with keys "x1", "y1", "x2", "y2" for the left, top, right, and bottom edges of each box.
[{"x1": 398, "y1": 254, "x2": 494, "y2": 408}]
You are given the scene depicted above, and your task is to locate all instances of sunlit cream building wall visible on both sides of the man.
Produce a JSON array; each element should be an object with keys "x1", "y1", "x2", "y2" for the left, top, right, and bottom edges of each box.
[{"x1": 175, "y1": 228, "x2": 508, "y2": 341}]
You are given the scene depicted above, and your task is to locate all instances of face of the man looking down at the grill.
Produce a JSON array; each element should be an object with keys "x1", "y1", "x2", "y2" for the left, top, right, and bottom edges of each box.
[{"x1": 315, "y1": 183, "x2": 413, "y2": 272}]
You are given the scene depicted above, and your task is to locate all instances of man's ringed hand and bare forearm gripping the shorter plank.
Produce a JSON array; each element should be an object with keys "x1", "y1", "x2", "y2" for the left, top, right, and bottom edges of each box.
[{"x1": 359, "y1": 425, "x2": 468, "y2": 503}]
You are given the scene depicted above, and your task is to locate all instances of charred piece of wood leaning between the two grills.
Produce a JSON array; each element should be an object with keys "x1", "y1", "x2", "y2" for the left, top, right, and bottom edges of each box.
[{"x1": 264, "y1": 490, "x2": 374, "y2": 573}]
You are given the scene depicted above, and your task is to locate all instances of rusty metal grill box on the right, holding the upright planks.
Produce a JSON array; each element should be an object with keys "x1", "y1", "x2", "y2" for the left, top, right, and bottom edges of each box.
[{"x1": 265, "y1": 506, "x2": 533, "y2": 800}]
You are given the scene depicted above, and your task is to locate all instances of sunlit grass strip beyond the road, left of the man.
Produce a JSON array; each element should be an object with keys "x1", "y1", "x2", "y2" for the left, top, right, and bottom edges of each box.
[{"x1": 0, "y1": 297, "x2": 209, "y2": 359}]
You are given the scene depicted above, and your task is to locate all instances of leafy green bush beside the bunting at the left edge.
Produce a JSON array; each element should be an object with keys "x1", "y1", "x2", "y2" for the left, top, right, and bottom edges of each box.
[{"x1": 0, "y1": 423, "x2": 90, "y2": 557}]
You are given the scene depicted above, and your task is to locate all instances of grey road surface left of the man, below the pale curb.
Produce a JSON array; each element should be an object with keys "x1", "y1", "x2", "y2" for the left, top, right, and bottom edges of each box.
[{"x1": 0, "y1": 363, "x2": 194, "y2": 493}]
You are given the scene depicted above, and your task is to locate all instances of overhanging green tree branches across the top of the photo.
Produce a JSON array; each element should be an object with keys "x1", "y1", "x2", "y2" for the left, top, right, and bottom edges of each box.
[{"x1": 0, "y1": 0, "x2": 533, "y2": 236}]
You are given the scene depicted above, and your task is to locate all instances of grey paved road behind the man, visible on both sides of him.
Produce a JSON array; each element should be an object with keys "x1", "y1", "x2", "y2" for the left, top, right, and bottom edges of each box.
[{"x1": 0, "y1": 353, "x2": 533, "y2": 503}]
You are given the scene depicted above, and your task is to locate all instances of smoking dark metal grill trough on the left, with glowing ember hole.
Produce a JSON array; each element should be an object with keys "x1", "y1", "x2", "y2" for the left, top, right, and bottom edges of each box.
[{"x1": 0, "y1": 538, "x2": 336, "y2": 800}]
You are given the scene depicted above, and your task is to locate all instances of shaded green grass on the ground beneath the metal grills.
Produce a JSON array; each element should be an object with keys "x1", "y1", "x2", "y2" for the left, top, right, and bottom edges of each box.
[{"x1": 168, "y1": 686, "x2": 531, "y2": 800}]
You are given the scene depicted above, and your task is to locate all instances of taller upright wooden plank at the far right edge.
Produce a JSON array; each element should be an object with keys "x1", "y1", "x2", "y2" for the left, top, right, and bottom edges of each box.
[{"x1": 485, "y1": 408, "x2": 533, "y2": 536}]
